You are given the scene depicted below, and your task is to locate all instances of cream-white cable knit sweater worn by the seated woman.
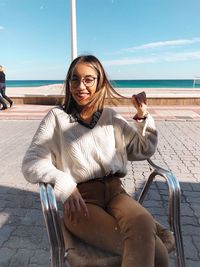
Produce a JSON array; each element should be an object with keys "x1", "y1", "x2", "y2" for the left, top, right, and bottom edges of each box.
[{"x1": 22, "y1": 107, "x2": 157, "y2": 203}]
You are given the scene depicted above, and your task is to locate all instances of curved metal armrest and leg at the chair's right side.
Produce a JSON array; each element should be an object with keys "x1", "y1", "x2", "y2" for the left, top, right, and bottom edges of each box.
[{"x1": 138, "y1": 159, "x2": 185, "y2": 267}]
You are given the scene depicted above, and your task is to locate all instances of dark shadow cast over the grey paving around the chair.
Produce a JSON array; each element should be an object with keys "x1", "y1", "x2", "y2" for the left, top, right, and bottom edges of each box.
[{"x1": 0, "y1": 178, "x2": 200, "y2": 267}]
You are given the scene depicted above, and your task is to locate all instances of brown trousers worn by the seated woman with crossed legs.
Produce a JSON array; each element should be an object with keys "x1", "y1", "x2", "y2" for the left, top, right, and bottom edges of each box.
[{"x1": 64, "y1": 177, "x2": 168, "y2": 267}]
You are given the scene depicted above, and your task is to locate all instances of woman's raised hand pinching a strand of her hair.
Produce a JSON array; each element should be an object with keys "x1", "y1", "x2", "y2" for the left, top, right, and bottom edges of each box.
[{"x1": 131, "y1": 92, "x2": 148, "y2": 118}]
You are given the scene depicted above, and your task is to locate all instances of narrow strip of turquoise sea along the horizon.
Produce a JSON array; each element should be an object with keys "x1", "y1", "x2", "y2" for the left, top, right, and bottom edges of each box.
[{"x1": 6, "y1": 79, "x2": 200, "y2": 88}]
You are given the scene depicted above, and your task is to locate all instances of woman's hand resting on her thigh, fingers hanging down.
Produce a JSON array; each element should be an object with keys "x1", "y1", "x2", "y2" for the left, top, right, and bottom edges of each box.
[{"x1": 64, "y1": 188, "x2": 89, "y2": 223}]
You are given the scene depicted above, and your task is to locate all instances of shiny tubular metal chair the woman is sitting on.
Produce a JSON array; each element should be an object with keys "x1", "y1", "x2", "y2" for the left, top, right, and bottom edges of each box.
[{"x1": 39, "y1": 159, "x2": 185, "y2": 267}]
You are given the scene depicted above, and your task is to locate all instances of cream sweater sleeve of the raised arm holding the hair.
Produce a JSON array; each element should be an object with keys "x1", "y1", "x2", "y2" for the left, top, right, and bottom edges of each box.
[{"x1": 113, "y1": 111, "x2": 158, "y2": 161}]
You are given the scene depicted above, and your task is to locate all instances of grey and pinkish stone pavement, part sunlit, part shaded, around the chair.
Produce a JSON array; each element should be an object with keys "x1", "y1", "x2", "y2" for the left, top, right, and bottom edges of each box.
[{"x1": 0, "y1": 105, "x2": 200, "y2": 267}]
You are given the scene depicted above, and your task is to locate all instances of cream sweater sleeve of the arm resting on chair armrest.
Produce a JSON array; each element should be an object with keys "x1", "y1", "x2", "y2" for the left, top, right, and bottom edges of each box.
[{"x1": 22, "y1": 109, "x2": 76, "y2": 203}]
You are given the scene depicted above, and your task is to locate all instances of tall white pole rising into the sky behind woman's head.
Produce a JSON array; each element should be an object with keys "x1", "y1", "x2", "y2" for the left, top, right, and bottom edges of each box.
[{"x1": 70, "y1": 0, "x2": 77, "y2": 60}]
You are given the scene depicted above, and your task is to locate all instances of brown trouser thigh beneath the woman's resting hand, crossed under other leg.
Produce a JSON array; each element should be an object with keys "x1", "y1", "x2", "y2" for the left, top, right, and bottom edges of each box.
[{"x1": 64, "y1": 203, "x2": 122, "y2": 255}]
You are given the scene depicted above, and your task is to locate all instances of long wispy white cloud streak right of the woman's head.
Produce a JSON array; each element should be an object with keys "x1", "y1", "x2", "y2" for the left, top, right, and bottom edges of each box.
[{"x1": 104, "y1": 37, "x2": 200, "y2": 66}]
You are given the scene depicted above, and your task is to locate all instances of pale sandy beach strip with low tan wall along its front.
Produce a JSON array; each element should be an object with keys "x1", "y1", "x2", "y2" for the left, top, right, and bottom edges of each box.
[{"x1": 6, "y1": 84, "x2": 200, "y2": 108}]
